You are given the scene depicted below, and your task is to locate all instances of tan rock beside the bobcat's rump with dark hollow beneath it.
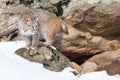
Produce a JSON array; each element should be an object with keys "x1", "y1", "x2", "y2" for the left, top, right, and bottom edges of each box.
[{"x1": 55, "y1": 23, "x2": 106, "y2": 64}]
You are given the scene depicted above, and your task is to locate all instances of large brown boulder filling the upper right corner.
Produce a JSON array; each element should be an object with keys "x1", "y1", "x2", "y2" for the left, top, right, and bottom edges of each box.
[{"x1": 63, "y1": 0, "x2": 120, "y2": 36}]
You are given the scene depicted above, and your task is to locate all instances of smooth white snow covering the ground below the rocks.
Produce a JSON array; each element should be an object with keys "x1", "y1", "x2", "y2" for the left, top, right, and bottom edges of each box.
[{"x1": 0, "y1": 41, "x2": 120, "y2": 80}]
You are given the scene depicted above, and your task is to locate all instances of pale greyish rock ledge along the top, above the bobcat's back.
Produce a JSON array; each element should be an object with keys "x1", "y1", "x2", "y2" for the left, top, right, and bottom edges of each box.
[{"x1": 0, "y1": 0, "x2": 58, "y2": 14}]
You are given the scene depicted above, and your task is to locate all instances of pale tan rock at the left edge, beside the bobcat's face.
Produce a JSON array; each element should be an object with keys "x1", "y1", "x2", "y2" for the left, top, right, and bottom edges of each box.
[{"x1": 0, "y1": 14, "x2": 19, "y2": 37}]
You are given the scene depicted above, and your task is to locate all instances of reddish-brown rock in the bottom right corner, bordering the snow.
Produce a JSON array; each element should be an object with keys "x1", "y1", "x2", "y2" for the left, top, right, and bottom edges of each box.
[{"x1": 81, "y1": 49, "x2": 120, "y2": 75}]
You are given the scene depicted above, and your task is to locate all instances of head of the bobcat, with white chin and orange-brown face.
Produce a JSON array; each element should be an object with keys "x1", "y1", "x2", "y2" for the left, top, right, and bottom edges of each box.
[{"x1": 18, "y1": 11, "x2": 39, "y2": 36}]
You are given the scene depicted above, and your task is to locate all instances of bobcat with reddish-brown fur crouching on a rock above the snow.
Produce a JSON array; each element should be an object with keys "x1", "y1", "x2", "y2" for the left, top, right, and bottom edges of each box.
[{"x1": 18, "y1": 9, "x2": 68, "y2": 49}]
